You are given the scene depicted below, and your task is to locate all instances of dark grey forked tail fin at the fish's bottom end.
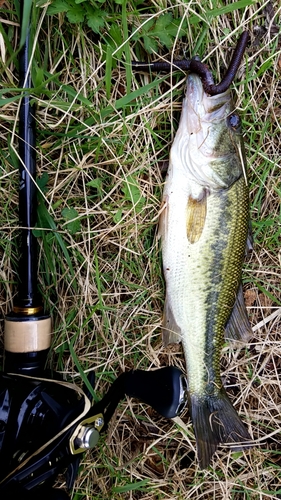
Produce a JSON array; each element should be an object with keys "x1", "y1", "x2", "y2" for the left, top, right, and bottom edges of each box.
[{"x1": 189, "y1": 388, "x2": 251, "y2": 469}]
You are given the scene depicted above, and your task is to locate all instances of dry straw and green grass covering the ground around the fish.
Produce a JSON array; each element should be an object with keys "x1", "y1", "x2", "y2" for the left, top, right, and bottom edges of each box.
[{"x1": 0, "y1": 0, "x2": 281, "y2": 500}]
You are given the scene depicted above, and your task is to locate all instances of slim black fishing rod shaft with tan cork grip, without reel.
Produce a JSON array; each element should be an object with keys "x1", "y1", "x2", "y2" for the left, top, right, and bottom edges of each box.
[{"x1": 4, "y1": 2, "x2": 52, "y2": 376}]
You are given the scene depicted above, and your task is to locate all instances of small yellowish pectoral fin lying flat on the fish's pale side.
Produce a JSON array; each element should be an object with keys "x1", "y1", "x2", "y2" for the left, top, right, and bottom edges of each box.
[{"x1": 186, "y1": 193, "x2": 207, "y2": 243}]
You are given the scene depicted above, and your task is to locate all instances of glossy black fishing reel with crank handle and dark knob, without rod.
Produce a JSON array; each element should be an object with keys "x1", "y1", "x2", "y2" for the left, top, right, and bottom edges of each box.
[{"x1": 0, "y1": 366, "x2": 187, "y2": 500}]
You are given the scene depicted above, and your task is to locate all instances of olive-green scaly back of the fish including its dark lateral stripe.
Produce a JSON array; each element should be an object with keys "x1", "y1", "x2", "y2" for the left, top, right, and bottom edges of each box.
[{"x1": 200, "y1": 177, "x2": 249, "y2": 386}]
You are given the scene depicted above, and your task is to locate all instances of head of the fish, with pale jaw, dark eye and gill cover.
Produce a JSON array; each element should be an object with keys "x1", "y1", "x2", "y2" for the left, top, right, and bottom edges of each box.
[{"x1": 171, "y1": 73, "x2": 244, "y2": 190}]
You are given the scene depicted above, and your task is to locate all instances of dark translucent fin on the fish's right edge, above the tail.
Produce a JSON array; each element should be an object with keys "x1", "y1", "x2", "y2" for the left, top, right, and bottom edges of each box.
[{"x1": 225, "y1": 285, "x2": 253, "y2": 342}]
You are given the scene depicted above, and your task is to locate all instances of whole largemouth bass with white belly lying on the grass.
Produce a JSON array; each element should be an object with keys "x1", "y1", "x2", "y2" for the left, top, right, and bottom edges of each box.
[{"x1": 158, "y1": 73, "x2": 252, "y2": 469}]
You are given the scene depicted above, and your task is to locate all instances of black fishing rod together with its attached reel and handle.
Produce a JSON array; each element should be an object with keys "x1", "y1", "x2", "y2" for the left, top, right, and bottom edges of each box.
[{"x1": 0, "y1": 0, "x2": 187, "y2": 500}]
